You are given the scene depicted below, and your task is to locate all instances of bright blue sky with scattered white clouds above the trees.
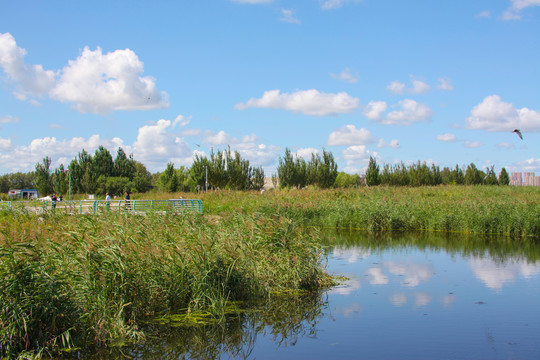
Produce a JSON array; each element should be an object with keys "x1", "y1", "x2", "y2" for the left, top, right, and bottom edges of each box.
[{"x1": 0, "y1": 0, "x2": 540, "y2": 176}]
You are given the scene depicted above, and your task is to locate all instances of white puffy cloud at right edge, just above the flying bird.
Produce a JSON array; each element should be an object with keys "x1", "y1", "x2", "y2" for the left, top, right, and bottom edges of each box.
[{"x1": 465, "y1": 95, "x2": 540, "y2": 133}]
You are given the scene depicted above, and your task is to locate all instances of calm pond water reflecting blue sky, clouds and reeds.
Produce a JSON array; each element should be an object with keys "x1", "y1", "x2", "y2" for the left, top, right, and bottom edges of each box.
[{"x1": 77, "y1": 232, "x2": 540, "y2": 360}]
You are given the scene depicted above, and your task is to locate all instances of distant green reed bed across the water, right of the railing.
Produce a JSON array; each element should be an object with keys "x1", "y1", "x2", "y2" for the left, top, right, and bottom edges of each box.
[{"x1": 156, "y1": 186, "x2": 540, "y2": 237}]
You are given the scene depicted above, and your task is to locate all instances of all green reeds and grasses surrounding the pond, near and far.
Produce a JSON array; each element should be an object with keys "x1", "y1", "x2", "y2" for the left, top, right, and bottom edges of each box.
[{"x1": 0, "y1": 186, "x2": 540, "y2": 358}]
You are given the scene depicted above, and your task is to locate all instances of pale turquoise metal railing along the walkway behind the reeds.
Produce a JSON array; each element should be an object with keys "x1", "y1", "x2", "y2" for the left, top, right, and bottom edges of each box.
[{"x1": 0, "y1": 199, "x2": 203, "y2": 214}]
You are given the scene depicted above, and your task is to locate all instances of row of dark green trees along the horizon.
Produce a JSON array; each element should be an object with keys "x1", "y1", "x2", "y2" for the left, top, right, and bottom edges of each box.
[{"x1": 0, "y1": 146, "x2": 510, "y2": 196}]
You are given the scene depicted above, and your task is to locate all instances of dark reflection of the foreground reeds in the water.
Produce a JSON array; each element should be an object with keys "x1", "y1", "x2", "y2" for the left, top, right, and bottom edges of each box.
[{"x1": 71, "y1": 292, "x2": 327, "y2": 360}]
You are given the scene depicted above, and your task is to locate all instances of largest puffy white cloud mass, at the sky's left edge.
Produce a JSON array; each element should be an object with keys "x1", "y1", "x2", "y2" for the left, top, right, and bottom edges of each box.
[{"x1": 0, "y1": 33, "x2": 169, "y2": 114}]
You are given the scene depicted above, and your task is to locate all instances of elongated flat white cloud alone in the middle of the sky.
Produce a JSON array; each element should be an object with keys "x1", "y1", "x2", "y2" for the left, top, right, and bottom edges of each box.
[{"x1": 235, "y1": 89, "x2": 360, "y2": 116}]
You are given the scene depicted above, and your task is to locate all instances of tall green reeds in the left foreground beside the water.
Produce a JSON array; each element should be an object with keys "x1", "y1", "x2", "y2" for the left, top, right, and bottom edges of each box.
[{"x1": 0, "y1": 211, "x2": 328, "y2": 357}]
